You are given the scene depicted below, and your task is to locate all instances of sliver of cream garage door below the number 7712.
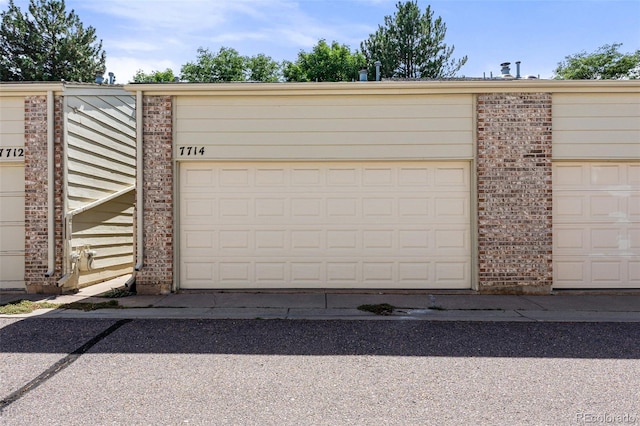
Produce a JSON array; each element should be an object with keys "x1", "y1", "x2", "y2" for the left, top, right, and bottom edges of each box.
[{"x1": 0, "y1": 163, "x2": 25, "y2": 290}]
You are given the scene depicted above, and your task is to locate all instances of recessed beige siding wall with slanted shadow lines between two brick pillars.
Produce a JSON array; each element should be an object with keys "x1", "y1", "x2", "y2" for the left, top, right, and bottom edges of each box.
[{"x1": 65, "y1": 93, "x2": 136, "y2": 285}]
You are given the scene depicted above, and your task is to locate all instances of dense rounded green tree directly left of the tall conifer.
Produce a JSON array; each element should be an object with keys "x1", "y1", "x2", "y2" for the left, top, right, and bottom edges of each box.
[{"x1": 284, "y1": 40, "x2": 366, "y2": 81}]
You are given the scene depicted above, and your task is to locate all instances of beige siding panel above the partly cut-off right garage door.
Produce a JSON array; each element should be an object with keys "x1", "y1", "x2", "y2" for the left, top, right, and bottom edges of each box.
[{"x1": 553, "y1": 93, "x2": 640, "y2": 160}]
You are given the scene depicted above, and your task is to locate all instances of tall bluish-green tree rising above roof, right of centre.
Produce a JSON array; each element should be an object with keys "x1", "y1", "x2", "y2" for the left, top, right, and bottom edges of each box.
[{"x1": 360, "y1": 0, "x2": 467, "y2": 78}]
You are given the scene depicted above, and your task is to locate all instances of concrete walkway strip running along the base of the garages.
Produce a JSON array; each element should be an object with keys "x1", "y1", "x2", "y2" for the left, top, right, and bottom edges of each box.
[{"x1": 0, "y1": 277, "x2": 640, "y2": 322}]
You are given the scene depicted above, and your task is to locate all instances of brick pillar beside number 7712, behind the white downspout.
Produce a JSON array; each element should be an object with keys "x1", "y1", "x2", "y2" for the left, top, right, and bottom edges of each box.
[{"x1": 24, "y1": 96, "x2": 63, "y2": 294}]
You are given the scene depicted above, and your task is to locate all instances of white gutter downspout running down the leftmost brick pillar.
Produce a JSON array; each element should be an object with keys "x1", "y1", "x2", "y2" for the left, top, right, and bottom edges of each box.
[{"x1": 44, "y1": 90, "x2": 56, "y2": 278}]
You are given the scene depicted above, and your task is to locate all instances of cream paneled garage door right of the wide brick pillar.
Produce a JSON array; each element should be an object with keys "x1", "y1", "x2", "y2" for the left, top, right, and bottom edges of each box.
[{"x1": 553, "y1": 163, "x2": 640, "y2": 288}]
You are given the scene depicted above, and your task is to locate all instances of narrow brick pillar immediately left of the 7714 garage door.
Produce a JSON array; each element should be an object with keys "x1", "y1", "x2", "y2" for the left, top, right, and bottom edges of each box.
[{"x1": 136, "y1": 96, "x2": 173, "y2": 294}]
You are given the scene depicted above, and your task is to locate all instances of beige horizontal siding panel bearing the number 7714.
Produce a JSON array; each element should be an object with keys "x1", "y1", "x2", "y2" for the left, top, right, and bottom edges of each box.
[{"x1": 175, "y1": 94, "x2": 474, "y2": 160}]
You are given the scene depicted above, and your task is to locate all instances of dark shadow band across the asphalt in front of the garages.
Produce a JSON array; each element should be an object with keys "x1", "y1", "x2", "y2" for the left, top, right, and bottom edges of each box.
[{"x1": 0, "y1": 318, "x2": 640, "y2": 359}]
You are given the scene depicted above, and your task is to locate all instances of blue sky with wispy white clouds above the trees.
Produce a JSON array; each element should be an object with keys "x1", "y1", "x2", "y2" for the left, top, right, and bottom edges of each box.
[{"x1": 0, "y1": 0, "x2": 640, "y2": 83}]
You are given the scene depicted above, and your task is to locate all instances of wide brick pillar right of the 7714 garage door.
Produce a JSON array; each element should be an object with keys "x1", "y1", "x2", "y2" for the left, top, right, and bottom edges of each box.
[{"x1": 477, "y1": 93, "x2": 553, "y2": 294}]
